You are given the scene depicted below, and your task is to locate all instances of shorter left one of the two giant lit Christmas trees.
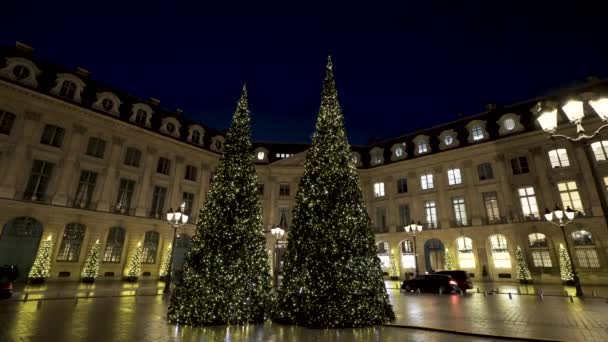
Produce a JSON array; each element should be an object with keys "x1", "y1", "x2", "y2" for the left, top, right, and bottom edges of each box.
[{"x1": 169, "y1": 87, "x2": 272, "y2": 326}]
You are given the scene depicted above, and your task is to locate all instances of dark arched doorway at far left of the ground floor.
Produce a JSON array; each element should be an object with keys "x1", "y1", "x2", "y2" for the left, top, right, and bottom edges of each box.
[{"x1": 0, "y1": 217, "x2": 42, "y2": 279}]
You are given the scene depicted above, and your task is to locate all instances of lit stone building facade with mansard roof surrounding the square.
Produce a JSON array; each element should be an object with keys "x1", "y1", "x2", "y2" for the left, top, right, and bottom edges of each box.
[{"x1": 0, "y1": 43, "x2": 608, "y2": 284}]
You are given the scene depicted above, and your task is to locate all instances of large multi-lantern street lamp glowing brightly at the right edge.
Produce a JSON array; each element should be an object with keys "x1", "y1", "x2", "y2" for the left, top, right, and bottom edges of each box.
[{"x1": 532, "y1": 97, "x2": 608, "y2": 228}]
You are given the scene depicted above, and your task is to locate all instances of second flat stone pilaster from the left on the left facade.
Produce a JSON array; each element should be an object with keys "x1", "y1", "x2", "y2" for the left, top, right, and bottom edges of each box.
[{"x1": 52, "y1": 124, "x2": 87, "y2": 206}]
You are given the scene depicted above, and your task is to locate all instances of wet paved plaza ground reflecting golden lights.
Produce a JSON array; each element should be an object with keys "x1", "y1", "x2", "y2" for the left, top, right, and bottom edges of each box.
[{"x1": 0, "y1": 282, "x2": 608, "y2": 342}]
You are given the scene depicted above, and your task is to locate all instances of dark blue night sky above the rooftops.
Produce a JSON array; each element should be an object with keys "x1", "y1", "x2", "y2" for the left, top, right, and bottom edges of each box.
[{"x1": 0, "y1": 0, "x2": 608, "y2": 144}]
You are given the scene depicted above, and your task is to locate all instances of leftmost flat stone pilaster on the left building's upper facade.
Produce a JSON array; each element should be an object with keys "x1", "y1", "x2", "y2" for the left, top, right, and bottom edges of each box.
[{"x1": 0, "y1": 112, "x2": 42, "y2": 198}]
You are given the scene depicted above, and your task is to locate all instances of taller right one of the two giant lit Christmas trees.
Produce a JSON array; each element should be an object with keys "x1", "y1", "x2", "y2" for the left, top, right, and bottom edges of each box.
[{"x1": 273, "y1": 59, "x2": 395, "y2": 328}]
